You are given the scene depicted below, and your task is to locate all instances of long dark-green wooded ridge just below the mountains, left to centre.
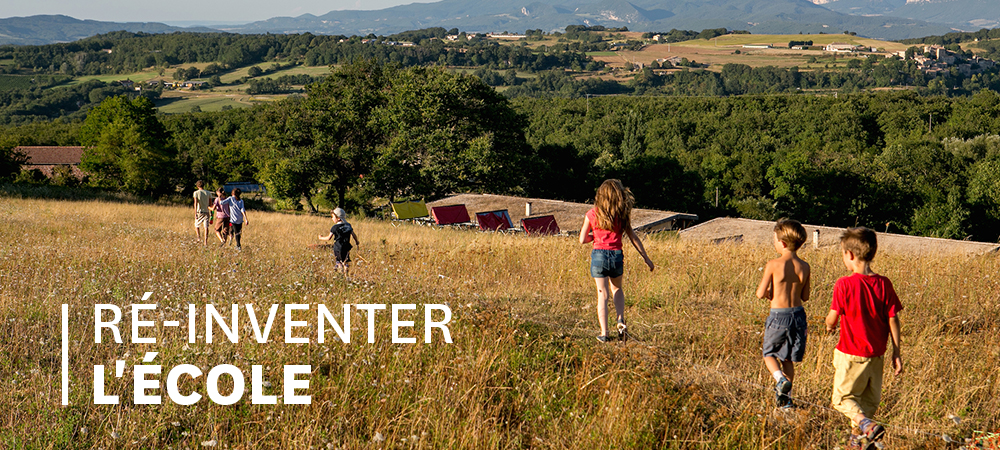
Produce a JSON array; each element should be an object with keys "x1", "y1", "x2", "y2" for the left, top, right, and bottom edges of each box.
[{"x1": 0, "y1": 28, "x2": 601, "y2": 79}]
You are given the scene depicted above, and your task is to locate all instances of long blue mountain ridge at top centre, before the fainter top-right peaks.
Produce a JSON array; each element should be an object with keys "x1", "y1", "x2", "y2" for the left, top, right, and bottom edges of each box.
[{"x1": 226, "y1": 0, "x2": 956, "y2": 39}]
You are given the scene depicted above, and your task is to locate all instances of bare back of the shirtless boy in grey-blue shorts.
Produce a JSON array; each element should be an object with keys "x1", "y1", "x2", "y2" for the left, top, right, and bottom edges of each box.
[{"x1": 757, "y1": 250, "x2": 810, "y2": 309}]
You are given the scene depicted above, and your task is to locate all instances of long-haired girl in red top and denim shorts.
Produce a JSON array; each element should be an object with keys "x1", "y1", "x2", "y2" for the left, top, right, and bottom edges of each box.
[{"x1": 580, "y1": 179, "x2": 653, "y2": 342}]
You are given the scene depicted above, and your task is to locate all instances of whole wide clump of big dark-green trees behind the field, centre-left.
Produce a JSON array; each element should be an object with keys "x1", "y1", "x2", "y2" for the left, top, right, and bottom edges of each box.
[{"x1": 262, "y1": 60, "x2": 529, "y2": 206}]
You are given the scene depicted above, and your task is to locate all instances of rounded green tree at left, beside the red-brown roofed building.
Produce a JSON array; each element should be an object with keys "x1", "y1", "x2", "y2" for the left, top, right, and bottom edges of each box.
[{"x1": 80, "y1": 96, "x2": 176, "y2": 196}]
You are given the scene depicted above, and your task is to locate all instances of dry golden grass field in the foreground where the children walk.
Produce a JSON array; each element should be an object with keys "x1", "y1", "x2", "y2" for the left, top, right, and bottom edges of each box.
[{"x1": 0, "y1": 198, "x2": 1000, "y2": 449}]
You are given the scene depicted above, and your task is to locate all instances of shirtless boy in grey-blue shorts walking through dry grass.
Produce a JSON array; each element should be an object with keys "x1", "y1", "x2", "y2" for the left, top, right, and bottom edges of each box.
[{"x1": 757, "y1": 219, "x2": 810, "y2": 409}]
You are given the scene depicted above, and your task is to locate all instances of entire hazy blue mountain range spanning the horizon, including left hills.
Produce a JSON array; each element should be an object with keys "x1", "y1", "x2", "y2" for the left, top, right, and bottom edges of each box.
[{"x1": 0, "y1": 0, "x2": 1000, "y2": 45}]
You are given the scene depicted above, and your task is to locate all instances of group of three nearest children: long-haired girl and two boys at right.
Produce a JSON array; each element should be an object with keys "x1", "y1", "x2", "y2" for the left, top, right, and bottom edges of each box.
[{"x1": 580, "y1": 179, "x2": 903, "y2": 450}]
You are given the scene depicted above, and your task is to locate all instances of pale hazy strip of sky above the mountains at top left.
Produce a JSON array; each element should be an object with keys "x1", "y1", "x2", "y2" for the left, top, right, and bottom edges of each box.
[{"x1": 0, "y1": 0, "x2": 437, "y2": 23}]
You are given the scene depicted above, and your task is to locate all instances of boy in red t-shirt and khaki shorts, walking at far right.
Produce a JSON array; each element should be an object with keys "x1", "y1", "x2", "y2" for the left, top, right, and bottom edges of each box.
[{"x1": 826, "y1": 227, "x2": 903, "y2": 448}]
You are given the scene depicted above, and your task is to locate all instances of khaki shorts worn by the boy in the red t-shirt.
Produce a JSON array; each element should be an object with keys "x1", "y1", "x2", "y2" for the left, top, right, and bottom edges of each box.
[{"x1": 831, "y1": 349, "x2": 885, "y2": 419}]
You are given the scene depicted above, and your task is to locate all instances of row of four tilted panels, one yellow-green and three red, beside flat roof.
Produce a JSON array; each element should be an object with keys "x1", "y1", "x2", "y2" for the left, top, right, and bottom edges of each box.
[{"x1": 390, "y1": 201, "x2": 560, "y2": 235}]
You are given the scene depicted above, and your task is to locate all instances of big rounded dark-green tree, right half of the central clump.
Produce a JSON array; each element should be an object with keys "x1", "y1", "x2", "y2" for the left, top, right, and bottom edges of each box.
[{"x1": 366, "y1": 68, "x2": 529, "y2": 198}]
